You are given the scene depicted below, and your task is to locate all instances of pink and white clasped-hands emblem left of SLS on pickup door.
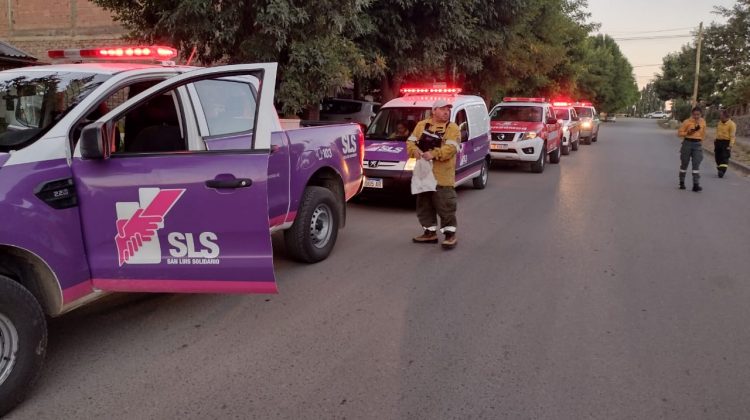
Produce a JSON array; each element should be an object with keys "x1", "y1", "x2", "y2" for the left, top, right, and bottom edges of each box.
[{"x1": 115, "y1": 188, "x2": 185, "y2": 267}]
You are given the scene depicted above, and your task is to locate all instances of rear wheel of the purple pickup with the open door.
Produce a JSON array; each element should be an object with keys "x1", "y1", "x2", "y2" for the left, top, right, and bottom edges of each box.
[{"x1": 284, "y1": 186, "x2": 341, "y2": 263}]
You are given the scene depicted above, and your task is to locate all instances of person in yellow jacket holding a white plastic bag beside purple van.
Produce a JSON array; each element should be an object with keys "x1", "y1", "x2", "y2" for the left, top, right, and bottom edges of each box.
[{"x1": 406, "y1": 99, "x2": 461, "y2": 249}]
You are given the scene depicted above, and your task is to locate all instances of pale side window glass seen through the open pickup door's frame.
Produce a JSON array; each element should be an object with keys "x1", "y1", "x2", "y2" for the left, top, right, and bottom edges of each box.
[{"x1": 194, "y1": 80, "x2": 256, "y2": 136}]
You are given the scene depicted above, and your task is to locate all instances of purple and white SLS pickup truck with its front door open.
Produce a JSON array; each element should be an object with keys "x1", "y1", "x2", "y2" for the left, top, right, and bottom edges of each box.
[{"x1": 0, "y1": 55, "x2": 364, "y2": 415}]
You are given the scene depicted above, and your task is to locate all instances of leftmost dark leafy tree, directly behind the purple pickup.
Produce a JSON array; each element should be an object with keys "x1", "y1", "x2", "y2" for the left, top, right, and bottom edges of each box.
[{"x1": 93, "y1": 0, "x2": 382, "y2": 117}]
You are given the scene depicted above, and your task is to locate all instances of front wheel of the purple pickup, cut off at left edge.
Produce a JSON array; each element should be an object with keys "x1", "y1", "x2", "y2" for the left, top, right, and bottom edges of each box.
[{"x1": 0, "y1": 276, "x2": 47, "y2": 416}]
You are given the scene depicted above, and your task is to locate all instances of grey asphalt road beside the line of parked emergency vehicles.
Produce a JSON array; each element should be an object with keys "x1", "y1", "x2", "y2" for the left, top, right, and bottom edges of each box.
[{"x1": 10, "y1": 119, "x2": 750, "y2": 419}]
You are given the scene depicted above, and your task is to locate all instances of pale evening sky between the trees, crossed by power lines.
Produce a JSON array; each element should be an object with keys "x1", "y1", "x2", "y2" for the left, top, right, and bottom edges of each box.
[{"x1": 589, "y1": 0, "x2": 736, "y2": 88}]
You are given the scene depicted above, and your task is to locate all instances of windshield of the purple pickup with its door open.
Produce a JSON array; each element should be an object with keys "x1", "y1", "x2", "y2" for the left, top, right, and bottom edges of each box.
[{"x1": 0, "y1": 70, "x2": 110, "y2": 152}]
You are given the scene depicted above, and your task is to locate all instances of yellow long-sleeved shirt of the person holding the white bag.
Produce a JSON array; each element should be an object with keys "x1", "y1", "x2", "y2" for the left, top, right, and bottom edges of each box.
[{"x1": 406, "y1": 118, "x2": 461, "y2": 187}]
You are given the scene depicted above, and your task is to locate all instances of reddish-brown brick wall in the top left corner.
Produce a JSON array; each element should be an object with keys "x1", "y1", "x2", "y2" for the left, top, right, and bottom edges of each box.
[{"x1": 0, "y1": 0, "x2": 125, "y2": 61}]
